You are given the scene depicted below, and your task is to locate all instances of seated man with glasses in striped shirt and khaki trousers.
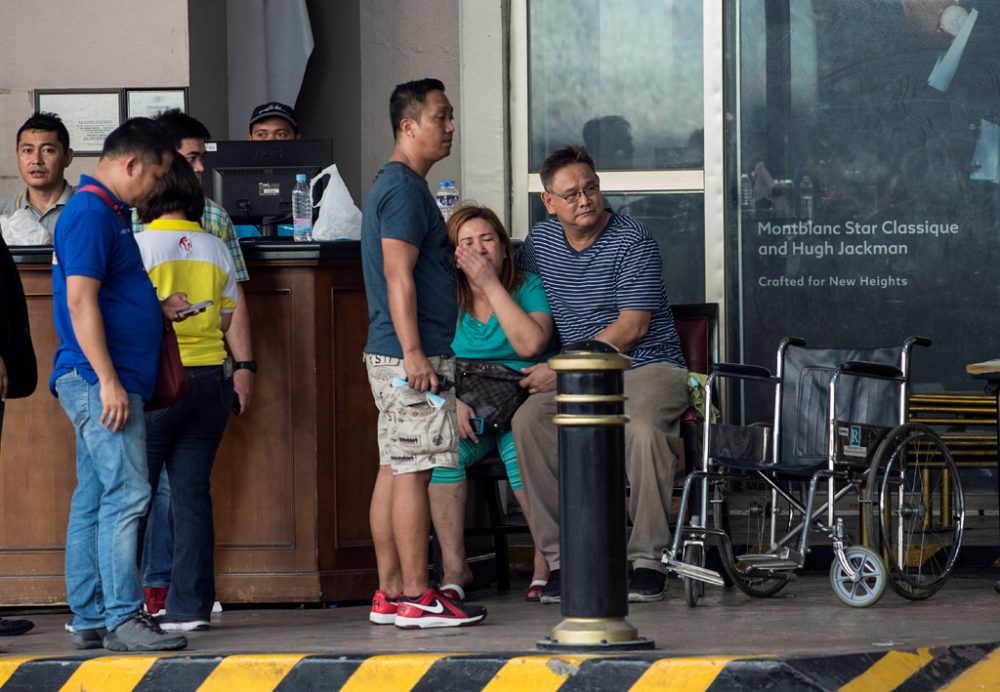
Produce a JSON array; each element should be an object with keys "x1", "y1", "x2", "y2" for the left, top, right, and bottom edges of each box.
[{"x1": 513, "y1": 146, "x2": 688, "y2": 603}]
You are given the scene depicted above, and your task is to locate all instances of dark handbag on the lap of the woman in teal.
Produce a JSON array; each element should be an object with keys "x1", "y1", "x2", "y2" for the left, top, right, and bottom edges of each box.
[{"x1": 455, "y1": 358, "x2": 528, "y2": 432}]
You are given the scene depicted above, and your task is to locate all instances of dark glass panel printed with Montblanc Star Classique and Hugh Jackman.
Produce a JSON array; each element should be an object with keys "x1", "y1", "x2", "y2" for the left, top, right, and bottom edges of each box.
[{"x1": 728, "y1": 0, "x2": 1000, "y2": 390}]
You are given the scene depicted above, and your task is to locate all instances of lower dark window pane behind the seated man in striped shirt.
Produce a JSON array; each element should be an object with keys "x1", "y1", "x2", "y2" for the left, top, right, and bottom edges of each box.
[{"x1": 531, "y1": 192, "x2": 705, "y2": 304}]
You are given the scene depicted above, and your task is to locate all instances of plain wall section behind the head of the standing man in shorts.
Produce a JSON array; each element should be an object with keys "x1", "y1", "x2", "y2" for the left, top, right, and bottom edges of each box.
[{"x1": 360, "y1": 0, "x2": 462, "y2": 200}]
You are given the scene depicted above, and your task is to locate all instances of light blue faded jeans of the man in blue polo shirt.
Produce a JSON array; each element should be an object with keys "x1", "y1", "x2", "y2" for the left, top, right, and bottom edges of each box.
[{"x1": 56, "y1": 371, "x2": 150, "y2": 630}]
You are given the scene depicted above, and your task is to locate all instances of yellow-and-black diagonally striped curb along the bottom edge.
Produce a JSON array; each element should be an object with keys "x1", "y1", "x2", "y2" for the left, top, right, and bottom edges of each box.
[{"x1": 0, "y1": 643, "x2": 1000, "y2": 692}]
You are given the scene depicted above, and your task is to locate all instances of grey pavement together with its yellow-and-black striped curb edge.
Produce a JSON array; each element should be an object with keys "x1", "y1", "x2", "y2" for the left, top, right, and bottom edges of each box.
[{"x1": 0, "y1": 567, "x2": 1000, "y2": 692}]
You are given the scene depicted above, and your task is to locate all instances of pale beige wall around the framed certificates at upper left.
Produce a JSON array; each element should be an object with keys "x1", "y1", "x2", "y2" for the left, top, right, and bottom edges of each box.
[{"x1": 0, "y1": 0, "x2": 188, "y2": 194}]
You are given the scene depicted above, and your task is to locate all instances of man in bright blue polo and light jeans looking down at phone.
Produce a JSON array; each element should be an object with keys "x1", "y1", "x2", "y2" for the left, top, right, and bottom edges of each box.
[{"x1": 49, "y1": 118, "x2": 193, "y2": 651}]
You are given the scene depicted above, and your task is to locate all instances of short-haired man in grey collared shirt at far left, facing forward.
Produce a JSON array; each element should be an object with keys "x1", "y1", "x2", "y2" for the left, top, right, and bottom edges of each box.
[{"x1": 0, "y1": 113, "x2": 73, "y2": 233}]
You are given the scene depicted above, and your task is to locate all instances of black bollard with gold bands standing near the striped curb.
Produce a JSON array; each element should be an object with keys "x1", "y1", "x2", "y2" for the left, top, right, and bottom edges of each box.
[{"x1": 538, "y1": 341, "x2": 653, "y2": 651}]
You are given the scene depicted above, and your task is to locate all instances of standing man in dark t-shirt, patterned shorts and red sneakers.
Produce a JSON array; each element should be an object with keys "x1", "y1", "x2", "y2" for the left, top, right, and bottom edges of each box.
[{"x1": 361, "y1": 79, "x2": 486, "y2": 629}]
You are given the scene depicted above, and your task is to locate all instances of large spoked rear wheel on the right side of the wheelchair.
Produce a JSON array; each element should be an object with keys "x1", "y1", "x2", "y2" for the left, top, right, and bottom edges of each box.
[{"x1": 865, "y1": 423, "x2": 965, "y2": 600}]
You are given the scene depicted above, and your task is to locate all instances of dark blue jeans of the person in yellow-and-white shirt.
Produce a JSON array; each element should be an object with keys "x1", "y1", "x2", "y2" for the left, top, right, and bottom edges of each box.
[{"x1": 146, "y1": 365, "x2": 234, "y2": 620}]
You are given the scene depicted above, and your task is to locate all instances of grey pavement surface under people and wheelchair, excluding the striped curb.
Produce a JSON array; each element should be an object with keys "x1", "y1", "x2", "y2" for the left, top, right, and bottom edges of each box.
[{"x1": 0, "y1": 568, "x2": 1000, "y2": 656}]
